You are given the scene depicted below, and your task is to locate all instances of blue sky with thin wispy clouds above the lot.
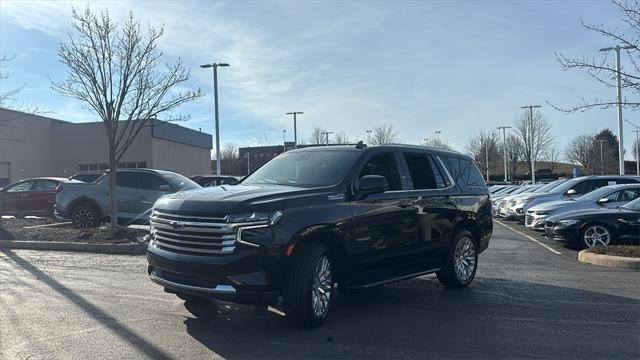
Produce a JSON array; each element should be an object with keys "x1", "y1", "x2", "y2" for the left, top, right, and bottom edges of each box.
[{"x1": 0, "y1": 0, "x2": 639, "y2": 158}]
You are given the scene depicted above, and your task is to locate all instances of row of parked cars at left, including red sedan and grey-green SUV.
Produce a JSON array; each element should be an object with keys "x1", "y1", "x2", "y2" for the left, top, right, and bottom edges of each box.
[{"x1": 0, "y1": 169, "x2": 240, "y2": 224}]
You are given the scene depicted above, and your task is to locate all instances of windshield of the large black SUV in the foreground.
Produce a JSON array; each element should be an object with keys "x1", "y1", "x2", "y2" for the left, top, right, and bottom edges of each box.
[{"x1": 242, "y1": 150, "x2": 360, "y2": 187}]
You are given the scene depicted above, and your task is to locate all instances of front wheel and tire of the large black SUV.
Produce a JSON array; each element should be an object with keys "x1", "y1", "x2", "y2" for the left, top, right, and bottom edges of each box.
[{"x1": 283, "y1": 243, "x2": 334, "y2": 328}]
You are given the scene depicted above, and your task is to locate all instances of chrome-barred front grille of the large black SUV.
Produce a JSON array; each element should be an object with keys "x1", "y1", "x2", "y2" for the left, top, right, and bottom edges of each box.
[{"x1": 150, "y1": 210, "x2": 236, "y2": 256}]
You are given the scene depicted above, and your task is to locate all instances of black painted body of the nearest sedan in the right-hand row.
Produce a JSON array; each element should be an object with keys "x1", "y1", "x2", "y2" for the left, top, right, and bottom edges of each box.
[{"x1": 545, "y1": 207, "x2": 640, "y2": 247}]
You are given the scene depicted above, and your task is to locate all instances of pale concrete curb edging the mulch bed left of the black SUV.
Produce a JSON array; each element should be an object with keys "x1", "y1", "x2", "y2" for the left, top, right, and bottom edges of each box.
[{"x1": 0, "y1": 240, "x2": 147, "y2": 255}]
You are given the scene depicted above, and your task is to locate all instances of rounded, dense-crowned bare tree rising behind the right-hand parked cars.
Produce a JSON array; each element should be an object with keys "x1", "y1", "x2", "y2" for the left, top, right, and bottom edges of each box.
[{"x1": 514, "y1": 110, "x2": 553, "y2": 176}]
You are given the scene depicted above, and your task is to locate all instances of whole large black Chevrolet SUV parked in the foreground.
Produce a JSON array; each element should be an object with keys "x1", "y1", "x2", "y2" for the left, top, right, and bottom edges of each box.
[{"x1": 147, "y1": 143, "x2": 493, "y2": 327}]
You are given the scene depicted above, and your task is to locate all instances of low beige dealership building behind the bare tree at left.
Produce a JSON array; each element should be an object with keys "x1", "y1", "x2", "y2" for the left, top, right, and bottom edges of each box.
[{"x1": 0, "y1": 108, "x2": 212, "y2": 186}]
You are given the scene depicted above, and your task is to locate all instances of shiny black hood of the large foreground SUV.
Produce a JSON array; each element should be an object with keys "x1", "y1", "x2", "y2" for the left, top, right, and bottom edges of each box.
[{"x1": 154, "y1": 185, "x2": 317, "y2": 216}]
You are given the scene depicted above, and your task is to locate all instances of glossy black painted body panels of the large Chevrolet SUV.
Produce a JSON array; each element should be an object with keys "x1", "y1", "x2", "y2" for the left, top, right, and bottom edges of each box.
[{"x1": 147, "y1": 145, "x2": 493, "y2": 304}]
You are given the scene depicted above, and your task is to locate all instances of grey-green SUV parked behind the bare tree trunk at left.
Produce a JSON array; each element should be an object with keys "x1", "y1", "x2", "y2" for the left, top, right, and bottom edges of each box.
[{"x1": 55, "y1": 169, "x2": 201, "y2": 228}]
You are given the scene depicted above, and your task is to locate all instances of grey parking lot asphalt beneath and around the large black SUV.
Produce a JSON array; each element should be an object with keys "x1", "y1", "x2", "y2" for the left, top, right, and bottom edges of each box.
[{"x1": 0, "y1": 222, "x2": 640, "y2": 359}]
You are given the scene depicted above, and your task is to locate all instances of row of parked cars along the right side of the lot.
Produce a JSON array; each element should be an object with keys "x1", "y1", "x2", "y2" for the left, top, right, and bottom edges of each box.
[{"x1": 491, "y1": 175, "x2": 640, "y2": 248}]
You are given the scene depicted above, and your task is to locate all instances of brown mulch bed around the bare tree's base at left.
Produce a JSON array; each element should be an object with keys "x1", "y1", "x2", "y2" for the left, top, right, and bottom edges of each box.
[{"x1": 0, "y1": 218, "x2": 148, "y2": 244}]
